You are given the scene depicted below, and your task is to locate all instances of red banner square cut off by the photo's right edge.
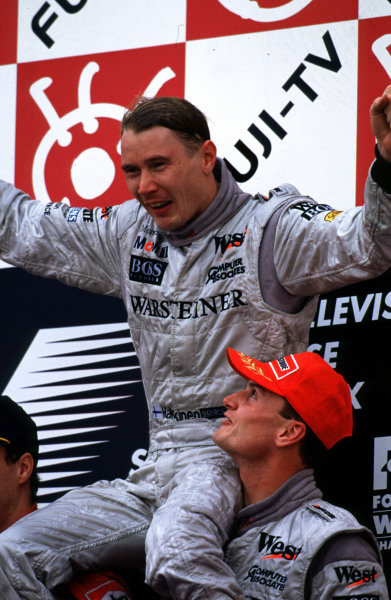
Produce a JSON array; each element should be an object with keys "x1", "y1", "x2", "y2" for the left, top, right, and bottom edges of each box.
[{"x1": 357, "y1": 17, "x2": 391, "y2": 205}]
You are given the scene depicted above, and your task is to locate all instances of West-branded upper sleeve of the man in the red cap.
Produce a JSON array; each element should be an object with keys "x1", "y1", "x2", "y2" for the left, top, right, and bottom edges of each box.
[{"x1": 305, "y1": 533, "x2": 388, "y2": 600}]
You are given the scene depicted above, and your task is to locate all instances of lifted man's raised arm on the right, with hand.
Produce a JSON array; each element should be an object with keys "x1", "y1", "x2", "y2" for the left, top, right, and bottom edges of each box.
[{"x1": 274, "y1": 86, "x2": 391, "y2": 296}]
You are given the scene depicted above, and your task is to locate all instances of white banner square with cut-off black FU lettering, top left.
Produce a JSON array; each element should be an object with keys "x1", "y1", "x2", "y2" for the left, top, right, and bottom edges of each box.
[{"x1": 18, "y1": 0, "x2": 186, "y2": 62}]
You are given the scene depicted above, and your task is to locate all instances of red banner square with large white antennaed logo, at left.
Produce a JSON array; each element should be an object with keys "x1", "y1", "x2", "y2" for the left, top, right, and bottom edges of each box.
[{"x1": 15, "y1": 44, "x2": 185, "y2": 208}]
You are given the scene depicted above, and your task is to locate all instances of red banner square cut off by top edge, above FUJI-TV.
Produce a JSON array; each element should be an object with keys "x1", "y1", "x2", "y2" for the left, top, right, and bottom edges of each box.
[{"x1": 187, "y1": 0, "x2": 358, "y2": 40}]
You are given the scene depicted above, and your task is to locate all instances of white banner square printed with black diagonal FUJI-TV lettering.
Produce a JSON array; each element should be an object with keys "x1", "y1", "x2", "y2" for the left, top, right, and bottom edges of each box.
[{"x1": 185, "y1": 21, "x2": 360, "y2": 210}]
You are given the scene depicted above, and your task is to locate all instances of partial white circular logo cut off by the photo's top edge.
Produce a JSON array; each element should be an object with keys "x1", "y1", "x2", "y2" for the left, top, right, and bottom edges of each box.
[{"x1": 219, "y1": 0, "x2": 313, "y2": 23}]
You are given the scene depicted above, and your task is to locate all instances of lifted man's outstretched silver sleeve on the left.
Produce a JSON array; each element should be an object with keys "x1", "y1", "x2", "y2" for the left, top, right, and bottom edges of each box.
[{"x1": 0, "y1": 181, "x2": 127, "y2": 296}]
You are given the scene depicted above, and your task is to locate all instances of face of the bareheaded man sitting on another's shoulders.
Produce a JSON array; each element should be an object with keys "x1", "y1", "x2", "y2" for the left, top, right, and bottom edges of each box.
[{"x1": 121, "y1": 126, "x2": 213, "y2": 230}]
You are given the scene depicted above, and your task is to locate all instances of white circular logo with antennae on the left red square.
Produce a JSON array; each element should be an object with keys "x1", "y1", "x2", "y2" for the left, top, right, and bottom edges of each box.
[{"x1": 30, "y1": 61, "x2": 175, "y2": 205}]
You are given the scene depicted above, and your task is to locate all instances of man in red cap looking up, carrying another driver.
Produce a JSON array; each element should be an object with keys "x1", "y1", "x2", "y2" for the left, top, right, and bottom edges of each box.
[{"x1": 213, "y1": 348, "x2": 388, "y2": 600}]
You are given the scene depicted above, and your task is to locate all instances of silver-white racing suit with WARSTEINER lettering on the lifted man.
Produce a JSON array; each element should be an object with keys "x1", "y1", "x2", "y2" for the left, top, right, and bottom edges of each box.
[{"x1": 0, "y1": 161, "x2": 391, "y2": 600}]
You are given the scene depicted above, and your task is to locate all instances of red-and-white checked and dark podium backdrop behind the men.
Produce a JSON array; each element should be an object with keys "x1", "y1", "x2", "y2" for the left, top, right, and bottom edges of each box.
[{"x1": 0, "y1": 0, "x2": 391, "y2": 582}]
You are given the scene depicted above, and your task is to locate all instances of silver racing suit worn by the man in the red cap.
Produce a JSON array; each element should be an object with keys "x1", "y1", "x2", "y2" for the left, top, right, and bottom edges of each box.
[{"x1": 226, "y1": 469, "x2": 388, "y2": 600}]
